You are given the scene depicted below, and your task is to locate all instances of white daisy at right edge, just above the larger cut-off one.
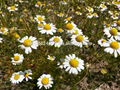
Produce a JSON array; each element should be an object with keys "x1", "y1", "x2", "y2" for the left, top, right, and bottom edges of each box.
[{"x1": 104, "y1": 27, "x2": 120, "y2": 40}]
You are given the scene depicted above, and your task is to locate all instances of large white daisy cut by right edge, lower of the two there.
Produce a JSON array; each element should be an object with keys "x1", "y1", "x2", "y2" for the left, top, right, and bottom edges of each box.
[{"x1": 104, "y1": 39, "x2": 120, "y2": 58}]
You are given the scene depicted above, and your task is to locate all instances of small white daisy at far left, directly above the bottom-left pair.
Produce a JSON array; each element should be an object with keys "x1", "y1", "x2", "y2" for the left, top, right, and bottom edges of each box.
[{"x1": 11, "y1": 53, "x2": 24, "y2": 65}]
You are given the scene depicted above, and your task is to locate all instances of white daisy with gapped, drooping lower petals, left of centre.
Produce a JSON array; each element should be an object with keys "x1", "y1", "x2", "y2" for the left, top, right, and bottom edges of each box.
[{"x1": 19, "y1": 36, "x2": 38, "y2": 54}]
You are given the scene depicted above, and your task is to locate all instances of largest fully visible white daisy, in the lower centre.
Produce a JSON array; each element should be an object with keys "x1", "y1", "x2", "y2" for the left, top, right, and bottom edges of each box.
[{"x1": 63, "y1": 54, "x2": 84, "y2": 74}]
